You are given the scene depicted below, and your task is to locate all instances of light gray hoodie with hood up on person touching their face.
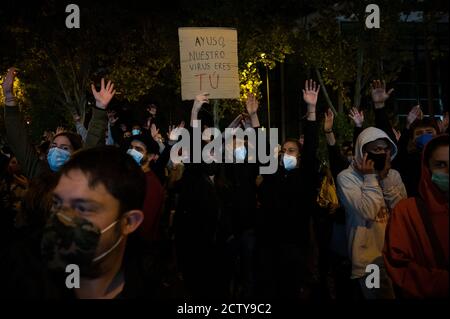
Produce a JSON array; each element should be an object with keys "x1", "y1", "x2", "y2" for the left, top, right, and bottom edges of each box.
[{"x1": 337, "y1": 127, "x2": 407, "y2": 278}]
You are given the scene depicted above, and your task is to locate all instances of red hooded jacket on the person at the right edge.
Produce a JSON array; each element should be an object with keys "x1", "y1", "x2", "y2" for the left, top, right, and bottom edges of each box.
[{"x1": 383, "y1": 136, "x2": 449, "y2": 298}]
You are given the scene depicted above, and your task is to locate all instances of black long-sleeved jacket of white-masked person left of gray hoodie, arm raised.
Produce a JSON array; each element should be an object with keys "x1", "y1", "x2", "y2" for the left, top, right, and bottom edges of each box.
[{"x1": 258, "y1": 121, "x2": 318, "y2": 243}]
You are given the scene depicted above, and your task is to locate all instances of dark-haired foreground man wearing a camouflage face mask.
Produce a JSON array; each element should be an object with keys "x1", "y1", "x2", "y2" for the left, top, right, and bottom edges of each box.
[{"x1": 0, "y1": 146, "x2": 164, "y2": 299}]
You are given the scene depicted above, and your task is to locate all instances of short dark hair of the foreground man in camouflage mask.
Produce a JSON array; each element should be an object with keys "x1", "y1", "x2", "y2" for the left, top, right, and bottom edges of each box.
[{"x1": 59, "y1": 146, "x2": 146, "y2": 214}]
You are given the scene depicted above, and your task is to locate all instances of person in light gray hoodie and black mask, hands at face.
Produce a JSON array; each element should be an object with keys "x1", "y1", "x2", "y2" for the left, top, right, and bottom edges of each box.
[{"x1": 337, "y1": 127, "x2": 407, "y2": 299}]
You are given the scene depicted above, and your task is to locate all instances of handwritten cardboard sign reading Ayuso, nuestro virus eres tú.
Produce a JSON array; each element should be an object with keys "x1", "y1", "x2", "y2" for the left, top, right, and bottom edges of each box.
[{"x1": 178, "y1": 28, "x2": 239, "y2": 100}]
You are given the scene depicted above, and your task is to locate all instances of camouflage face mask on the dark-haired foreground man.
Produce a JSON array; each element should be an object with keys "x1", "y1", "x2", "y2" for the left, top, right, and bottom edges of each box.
[{"x1": 41, "y1": 210, "x2": 122, "y2": 277}]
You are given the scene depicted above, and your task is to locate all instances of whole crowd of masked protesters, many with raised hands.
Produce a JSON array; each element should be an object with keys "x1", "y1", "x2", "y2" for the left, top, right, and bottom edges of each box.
[{"x1": 0, "y1": 68, "x2": 449, "y2": 301}]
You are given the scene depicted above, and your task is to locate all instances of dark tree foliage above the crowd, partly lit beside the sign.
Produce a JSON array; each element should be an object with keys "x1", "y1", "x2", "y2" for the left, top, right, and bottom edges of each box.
[{"x1": 0, "y1": 0, "x2": 446, "y2": 142}]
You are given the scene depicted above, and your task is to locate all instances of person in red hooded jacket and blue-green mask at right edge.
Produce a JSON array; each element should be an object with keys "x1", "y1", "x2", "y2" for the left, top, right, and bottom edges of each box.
[{"x1": 383, "y1": 135, "x2": 449, "y2": 298}]
